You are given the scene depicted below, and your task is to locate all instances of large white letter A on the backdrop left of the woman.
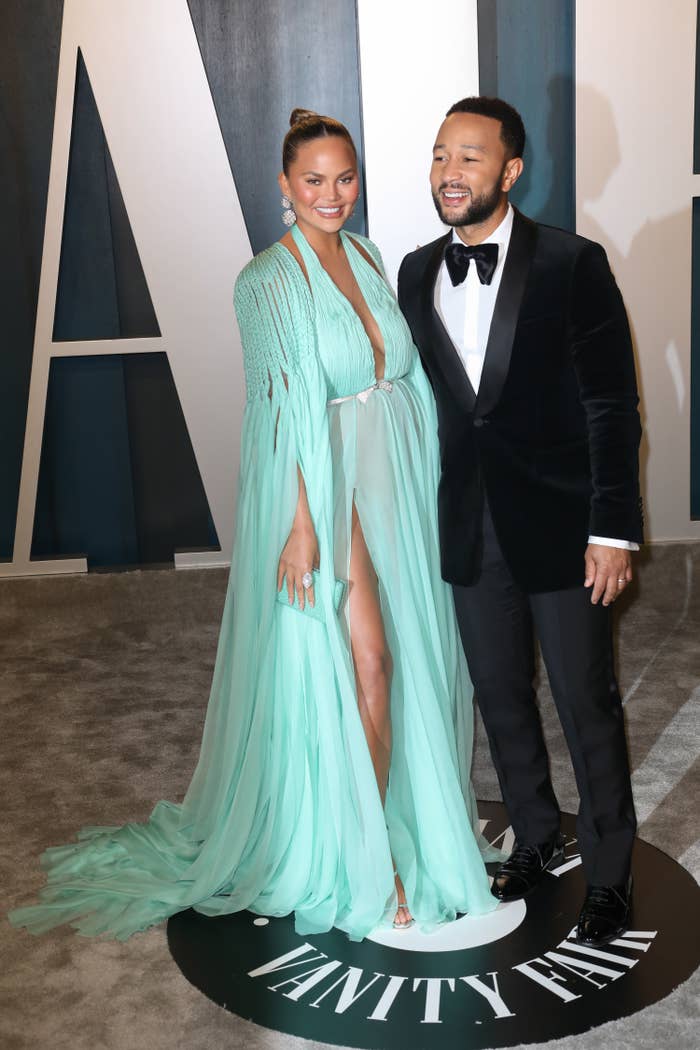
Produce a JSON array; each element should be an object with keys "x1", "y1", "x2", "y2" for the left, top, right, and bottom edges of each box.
[{"x1": 0, "y1": 0, "x2": 251, "y2": 576}]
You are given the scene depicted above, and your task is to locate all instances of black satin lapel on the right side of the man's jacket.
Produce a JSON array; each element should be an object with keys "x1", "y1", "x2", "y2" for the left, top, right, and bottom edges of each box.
[{"x1": 474, "y1": 211, "x2": 537, "y2": 417}]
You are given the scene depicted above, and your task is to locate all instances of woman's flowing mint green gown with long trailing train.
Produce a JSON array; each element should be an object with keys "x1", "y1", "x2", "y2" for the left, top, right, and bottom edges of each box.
[{"x1": 9, "y1": 227, "x2": 500, "y2": 939}]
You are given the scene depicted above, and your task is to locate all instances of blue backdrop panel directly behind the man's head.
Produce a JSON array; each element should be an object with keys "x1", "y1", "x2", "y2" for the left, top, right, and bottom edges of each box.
[{"x1": 479, "y1": 0, "x2": 576, "y2": 230}]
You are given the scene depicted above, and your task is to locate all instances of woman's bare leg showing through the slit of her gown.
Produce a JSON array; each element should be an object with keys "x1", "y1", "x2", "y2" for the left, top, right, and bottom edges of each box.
[{"x1": 349, "y1": 504, "x2": 411, "y2": 925}]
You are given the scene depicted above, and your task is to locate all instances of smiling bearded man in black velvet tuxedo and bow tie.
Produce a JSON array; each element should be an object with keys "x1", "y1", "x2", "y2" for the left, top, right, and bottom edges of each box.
[{"x1": 399, "y1": 98, "x2": 642, "y2": 946}]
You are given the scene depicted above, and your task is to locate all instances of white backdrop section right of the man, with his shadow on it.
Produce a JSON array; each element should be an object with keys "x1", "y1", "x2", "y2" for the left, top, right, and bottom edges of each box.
[{"x1": 576, "y1": 0, "x2": 700, "y2": 540}]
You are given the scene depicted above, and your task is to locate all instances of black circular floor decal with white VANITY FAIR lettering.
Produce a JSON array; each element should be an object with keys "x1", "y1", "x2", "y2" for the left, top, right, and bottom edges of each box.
[{"x1": 168, "y1": 802, "x2": 700, "y2": 1050}]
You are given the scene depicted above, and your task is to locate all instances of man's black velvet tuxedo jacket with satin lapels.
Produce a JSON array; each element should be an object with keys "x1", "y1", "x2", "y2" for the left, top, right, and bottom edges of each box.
[{"x1": 399, "y1": 211, "x2": 642, "y2": 592}]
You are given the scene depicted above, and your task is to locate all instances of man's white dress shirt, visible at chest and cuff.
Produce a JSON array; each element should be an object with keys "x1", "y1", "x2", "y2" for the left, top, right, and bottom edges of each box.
[{"x1": 434, "y1": 204, "x2": 639, "y2": 550}]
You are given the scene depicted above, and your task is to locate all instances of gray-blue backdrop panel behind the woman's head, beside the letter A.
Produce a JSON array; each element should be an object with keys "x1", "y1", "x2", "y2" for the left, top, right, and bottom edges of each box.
[{"x1": 189, "y1": 0, "x2": 365, "y2": 253}]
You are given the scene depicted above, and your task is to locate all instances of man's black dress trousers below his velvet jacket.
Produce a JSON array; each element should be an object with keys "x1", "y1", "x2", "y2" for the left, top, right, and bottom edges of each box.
[{"x1": 453, "y1": 507, "x2": 636, "y2": 885}]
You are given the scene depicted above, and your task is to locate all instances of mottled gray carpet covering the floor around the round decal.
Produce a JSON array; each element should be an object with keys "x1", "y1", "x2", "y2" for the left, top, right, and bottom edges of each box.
[{"x1": 0, "y1": 545, "x2": 700, "y2": 1050}]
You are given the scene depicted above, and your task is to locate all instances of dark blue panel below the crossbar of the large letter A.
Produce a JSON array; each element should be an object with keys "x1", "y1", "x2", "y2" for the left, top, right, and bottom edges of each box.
[{"x1": 31, "y1": 354, "x2": 216, "y2": 568}]
